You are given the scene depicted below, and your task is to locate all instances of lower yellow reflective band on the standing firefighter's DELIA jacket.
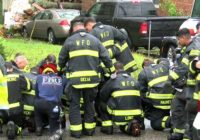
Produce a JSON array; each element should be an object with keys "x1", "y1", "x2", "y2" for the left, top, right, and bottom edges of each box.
[{"x1": 66, "y1": 70, "x2": 99, "y2": 78}]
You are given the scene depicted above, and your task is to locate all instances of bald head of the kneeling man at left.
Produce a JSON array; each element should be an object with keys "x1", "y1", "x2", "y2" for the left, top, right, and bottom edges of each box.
[{"x1": 15, "y1": 55, "x2": 28, "y2": 70}]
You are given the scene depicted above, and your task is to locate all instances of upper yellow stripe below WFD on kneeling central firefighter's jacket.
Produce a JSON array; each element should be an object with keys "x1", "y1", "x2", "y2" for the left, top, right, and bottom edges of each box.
[{"x1": 112, "y1": 90, "x2": 140, "y2": 98}]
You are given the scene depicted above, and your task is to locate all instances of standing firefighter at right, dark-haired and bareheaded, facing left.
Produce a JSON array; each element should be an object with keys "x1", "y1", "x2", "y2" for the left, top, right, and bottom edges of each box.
[{"x1": 168, "y1": 28, "x2": 200, "y2": 140}]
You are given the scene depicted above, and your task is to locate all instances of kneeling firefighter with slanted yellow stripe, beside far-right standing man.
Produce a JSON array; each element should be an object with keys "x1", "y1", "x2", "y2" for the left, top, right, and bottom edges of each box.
[{"x1": 138, "y1": 58, "x2": 173, "y2": 131}]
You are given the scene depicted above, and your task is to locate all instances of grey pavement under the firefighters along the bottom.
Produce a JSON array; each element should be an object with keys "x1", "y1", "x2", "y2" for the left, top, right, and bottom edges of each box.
[{"x1": 0, "y1": 121, "x2": 169, "y2": 140}]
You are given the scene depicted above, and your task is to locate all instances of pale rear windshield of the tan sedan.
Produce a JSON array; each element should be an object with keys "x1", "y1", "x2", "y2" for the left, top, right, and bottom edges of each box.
[{"x1": 57, "y1": 10, "x2": 80, "y2": 21}]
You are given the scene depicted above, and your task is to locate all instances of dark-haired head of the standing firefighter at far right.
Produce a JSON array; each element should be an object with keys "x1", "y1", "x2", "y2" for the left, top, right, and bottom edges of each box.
[{"x1": 176, "y1": 28, "x2": 191, "y2": 47}]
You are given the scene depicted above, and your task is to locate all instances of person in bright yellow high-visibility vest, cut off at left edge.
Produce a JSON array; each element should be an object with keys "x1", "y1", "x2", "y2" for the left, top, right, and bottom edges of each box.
[{"x1": 0, "y1": 55, "x2": 9, "y2": 134}]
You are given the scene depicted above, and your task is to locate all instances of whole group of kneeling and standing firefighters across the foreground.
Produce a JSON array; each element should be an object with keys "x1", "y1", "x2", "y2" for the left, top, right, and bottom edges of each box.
[{"x1": 0, "y1": 18, "x2": 200, "y2": 140}]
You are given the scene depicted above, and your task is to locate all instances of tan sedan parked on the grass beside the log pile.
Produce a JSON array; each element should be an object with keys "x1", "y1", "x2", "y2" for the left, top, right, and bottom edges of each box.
[{"x1": 22, "y1": 9, "x2": 80, "y2": 43}]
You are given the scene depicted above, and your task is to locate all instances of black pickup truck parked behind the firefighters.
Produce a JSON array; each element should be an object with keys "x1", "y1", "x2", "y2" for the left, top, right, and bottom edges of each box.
[{"x1": 79, "y1": 0, "x2": 187, "y2": 50}]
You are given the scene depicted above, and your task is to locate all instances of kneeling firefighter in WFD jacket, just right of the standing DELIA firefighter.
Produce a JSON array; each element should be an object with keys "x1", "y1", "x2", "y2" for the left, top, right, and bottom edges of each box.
[{"x1": 100, "y1": 62, "x2": 142, "y2": 136}]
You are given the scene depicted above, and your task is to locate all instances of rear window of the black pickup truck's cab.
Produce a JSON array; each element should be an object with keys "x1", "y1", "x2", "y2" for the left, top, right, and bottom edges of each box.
[{"x1": 118, "y1": 3, "x2": 142, "y2": 17}]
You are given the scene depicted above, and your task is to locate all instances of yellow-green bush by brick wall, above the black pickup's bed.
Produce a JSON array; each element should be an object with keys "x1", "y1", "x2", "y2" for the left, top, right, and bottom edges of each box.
[{"x1": 160, "y1": 0, "x2": 183, "y2": 16}]
